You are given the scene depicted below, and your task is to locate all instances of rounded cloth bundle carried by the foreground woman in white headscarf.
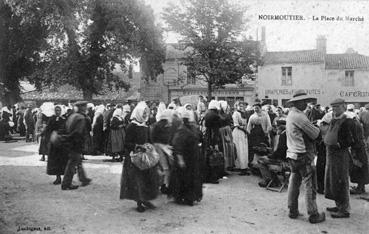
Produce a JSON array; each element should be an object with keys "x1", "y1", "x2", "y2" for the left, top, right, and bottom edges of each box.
[{"x1": 130, "y1": 143, "x2": 160, "y2": 170}]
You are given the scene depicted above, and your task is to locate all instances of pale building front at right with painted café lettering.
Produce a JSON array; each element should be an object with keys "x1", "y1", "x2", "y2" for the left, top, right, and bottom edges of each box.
[{"x1": 256, "y1": 36, "x2": 369, "y2": 107}]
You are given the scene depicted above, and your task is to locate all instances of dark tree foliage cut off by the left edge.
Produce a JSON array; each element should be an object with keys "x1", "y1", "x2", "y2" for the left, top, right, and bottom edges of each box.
[{"x1": 0, "y1": 0, "x2": 47, "y2": 105}]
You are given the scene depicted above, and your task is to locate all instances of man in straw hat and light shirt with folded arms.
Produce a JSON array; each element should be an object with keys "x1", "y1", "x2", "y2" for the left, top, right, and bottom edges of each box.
[{"x1": 286, "y1": 90, "x2": 325, "y2": 223}]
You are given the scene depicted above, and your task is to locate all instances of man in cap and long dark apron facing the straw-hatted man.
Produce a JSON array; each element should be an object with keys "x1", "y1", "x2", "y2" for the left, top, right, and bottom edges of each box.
[{"x1": 324, "y1": 98, "x2": 358, "y2": 218}]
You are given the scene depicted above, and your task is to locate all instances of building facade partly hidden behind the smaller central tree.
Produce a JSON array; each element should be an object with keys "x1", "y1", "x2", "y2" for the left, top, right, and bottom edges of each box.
[{"x1": 140, "y1": 44, "x2": 255, "y2": 104}]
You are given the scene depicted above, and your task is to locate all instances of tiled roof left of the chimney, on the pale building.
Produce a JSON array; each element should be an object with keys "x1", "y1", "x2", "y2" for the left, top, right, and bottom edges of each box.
[{"x1": 263, "y1": 50, "x2": 324, "y2": 65}]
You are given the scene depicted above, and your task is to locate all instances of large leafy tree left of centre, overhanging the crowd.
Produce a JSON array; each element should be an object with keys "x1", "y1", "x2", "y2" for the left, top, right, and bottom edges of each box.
[{"x1": 35, "y1": 0, "x2": 165, "y2": 100}]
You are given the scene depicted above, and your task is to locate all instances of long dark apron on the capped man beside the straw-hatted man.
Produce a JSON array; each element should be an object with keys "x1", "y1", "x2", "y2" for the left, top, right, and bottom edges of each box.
[{"x1": 324, "y1": 146, "x2": 350, "y2": 201}]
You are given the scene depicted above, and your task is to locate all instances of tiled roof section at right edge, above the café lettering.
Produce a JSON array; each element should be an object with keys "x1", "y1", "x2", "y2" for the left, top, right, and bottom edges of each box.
[{"x1": 325, "y1": 53, "x2": 369, "y2": 69}]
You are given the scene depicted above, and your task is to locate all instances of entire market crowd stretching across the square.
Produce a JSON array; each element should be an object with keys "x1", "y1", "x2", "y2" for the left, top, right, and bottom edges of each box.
[{"x1": 0, "y1": 90, "x2": 369, "y2": 220}]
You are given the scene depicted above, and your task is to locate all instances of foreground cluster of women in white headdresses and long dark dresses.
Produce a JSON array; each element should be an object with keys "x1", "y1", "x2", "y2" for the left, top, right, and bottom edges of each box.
[{"x1": 120, "y1": 102, "x2": 202, "y2": 212}]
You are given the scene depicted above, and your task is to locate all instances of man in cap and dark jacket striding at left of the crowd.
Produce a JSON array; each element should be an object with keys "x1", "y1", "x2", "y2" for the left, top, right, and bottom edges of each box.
[{"x1": 61, "y1": 101, "x2": 91, "y2": 190}]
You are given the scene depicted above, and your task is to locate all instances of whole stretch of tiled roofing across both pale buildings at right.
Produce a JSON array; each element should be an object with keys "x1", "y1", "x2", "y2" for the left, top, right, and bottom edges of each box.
[{"x1": 263, "y1": 50, "x2": 369, "y2": 69}]
